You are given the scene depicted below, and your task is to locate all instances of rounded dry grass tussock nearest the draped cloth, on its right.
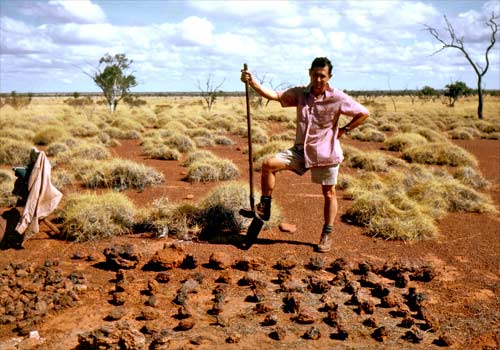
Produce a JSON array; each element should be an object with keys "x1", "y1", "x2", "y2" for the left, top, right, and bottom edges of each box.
[{"x1": 57, "y1": 192, "x2": 136, "y2": 242}]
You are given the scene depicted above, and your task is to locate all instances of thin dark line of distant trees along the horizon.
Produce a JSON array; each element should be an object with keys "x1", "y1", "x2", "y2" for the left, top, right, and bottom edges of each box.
[{"x1": 0, "y1": 89, "x2": 500, "y2": 97}]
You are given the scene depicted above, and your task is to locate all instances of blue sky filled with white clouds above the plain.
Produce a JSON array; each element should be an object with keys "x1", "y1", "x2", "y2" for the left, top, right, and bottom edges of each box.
[{"x1": 0, "y1": 0, "x2": 500, "y2": 92}]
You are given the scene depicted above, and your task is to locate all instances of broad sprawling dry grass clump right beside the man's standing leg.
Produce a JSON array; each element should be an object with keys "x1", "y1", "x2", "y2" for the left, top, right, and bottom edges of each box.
[{"x1": 340, "y1": 165, "x2": 496, "y2": 240}]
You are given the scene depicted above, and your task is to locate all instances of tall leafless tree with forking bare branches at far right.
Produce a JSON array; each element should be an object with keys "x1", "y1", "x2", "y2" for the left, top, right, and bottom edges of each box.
[{"x1": 425, "y1": 13, "x2": 500, "y2": 119}]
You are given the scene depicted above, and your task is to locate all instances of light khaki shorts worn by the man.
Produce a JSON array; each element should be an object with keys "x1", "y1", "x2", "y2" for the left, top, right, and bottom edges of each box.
[{"x1": 276, "y1": 145, "x2": 340, "y2": 185}]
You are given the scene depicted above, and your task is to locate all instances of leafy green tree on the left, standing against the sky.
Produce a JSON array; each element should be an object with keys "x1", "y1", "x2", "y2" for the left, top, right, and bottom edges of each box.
[{"x1": 87, "y1": 53, "x2": 137, "y2": 113}]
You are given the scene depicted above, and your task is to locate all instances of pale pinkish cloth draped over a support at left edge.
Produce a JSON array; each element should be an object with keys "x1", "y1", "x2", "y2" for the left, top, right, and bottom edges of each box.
[{"x1": 16, "y1": 147, "x2": 63, "y2": 234}]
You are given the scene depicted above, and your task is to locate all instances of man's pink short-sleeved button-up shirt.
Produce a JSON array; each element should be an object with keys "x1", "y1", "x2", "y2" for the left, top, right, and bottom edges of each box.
[{"x1": 277, "y1": 86, "x2": 368, "y2": 168}]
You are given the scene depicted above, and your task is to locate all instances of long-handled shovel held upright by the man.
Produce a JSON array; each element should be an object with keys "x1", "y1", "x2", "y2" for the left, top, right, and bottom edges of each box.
[{"x1": 243, "y1": 63, "x2": 264, "y2": 249}]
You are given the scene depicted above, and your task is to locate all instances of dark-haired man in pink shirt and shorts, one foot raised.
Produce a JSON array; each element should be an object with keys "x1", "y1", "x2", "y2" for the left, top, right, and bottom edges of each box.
[{"x1": 241, "y1": 57, "x2": 369, "y2": 253}]
